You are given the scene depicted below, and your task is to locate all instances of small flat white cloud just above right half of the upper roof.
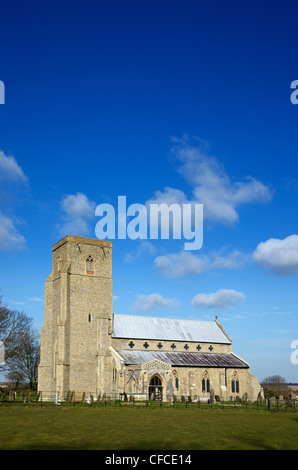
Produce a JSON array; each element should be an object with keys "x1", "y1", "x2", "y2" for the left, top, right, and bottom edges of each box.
[{"x1": 191, "y1": 289, "x2": 245, "y2": 309}]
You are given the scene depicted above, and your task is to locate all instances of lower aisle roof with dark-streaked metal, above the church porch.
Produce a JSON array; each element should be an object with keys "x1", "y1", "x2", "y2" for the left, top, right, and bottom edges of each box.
[{"x1": 116, "y1": 349, "x2": 249, "y2": 368}]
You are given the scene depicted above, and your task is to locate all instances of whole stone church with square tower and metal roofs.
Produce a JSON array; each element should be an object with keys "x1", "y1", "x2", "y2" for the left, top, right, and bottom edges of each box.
[{"x1": 38, "y1": 235, "x2": 261, "y2": 401}]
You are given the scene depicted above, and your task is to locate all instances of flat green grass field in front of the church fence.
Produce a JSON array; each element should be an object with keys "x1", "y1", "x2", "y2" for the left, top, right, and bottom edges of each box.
[{"x1": 0, "y1": 406, "x2": 298, "y2": 450}]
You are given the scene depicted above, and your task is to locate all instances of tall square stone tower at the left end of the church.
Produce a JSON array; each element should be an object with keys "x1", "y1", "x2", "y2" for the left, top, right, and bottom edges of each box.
[{"x1": 38, "y1": 235, "x2": 113, "y2": 394}]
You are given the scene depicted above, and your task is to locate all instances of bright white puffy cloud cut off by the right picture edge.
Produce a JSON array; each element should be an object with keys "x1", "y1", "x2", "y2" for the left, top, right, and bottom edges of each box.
[{"x1": 252, "y1": 235, "x2": 298, "y2": 275}]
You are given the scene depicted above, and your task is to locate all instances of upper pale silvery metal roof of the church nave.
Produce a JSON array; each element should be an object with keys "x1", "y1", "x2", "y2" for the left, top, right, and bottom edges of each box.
[{"x1": 112, "y1": 314, "x2": 231, "y2": 344}]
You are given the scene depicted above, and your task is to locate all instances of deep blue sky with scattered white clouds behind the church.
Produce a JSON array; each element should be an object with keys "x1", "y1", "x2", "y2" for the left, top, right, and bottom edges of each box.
[{"x1": 0, "y1": 0, "x2": 298, "y2": 382}]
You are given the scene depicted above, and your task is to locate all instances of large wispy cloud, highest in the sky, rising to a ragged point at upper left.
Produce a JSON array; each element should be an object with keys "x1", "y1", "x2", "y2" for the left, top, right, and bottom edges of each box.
[{"x1": 147, "y1": 136, "x2": 273, "y2": 225}]
